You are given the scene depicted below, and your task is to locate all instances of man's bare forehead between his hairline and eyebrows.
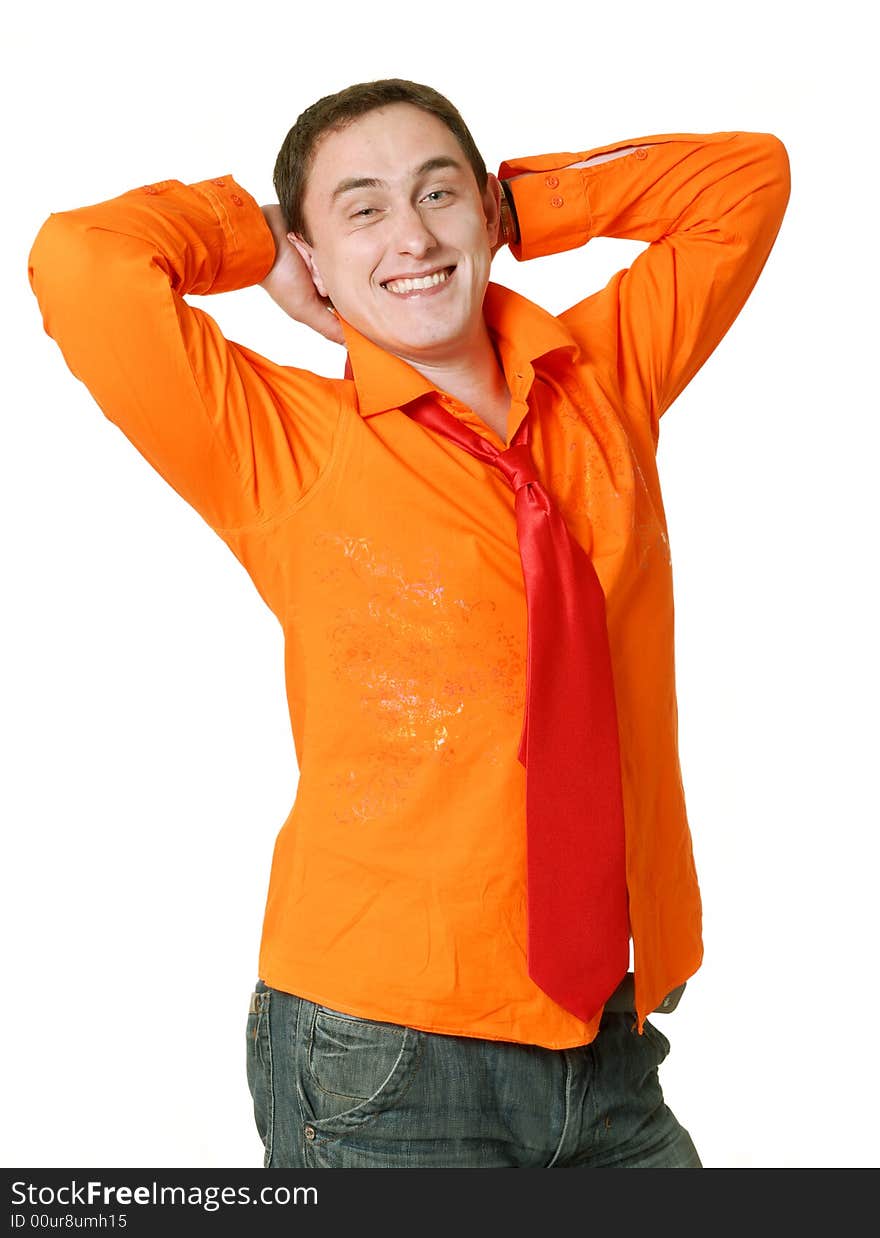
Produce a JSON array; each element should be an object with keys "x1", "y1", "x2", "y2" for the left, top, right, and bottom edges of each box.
[{"x1": 308, "y1": 103, "x2": 468, "y2": 194}]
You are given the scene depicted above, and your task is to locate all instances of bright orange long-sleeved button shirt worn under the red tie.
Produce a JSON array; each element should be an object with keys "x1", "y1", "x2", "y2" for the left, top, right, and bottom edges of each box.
[{"x1": 28, "y1": 132, "x2": 788, "y2": 1049}]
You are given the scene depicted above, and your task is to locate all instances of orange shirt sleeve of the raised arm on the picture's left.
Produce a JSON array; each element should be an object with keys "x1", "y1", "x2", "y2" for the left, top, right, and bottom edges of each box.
[{"x1": 28, "y1": 175, "x2": 338, "y2": 531}]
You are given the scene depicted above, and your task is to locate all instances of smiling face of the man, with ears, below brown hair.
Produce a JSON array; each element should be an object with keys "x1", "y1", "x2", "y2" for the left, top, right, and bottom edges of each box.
[{"x1": 295, "y1": 103, "x2": 500, "y2": 364}]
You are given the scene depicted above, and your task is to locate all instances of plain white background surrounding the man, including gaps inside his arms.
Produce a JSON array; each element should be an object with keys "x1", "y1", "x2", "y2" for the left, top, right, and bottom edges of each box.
[{"x1": 0, "y1": 0, "x2": 880, "y2": 1167}]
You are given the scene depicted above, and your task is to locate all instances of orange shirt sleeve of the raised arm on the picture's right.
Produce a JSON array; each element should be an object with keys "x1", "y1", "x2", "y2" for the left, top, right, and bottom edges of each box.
[{"x1": 499, "y1": 132, "x2": 790, "y2": 444}]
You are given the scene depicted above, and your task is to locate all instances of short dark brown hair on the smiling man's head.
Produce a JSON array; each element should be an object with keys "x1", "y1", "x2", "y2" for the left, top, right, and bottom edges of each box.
[{"x1": 272, "y1": 78, "x2": 486, "y2": 244}]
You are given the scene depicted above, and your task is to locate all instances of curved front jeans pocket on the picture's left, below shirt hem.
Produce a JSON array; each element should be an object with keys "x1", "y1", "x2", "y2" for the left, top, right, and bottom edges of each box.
[{"x1": 301, "y1": 1005, "x2": 423, "y2": 1138}]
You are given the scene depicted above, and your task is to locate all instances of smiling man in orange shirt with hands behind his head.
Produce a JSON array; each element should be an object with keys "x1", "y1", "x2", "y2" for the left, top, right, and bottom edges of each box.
[{"x1": 30, "y1": 79, "x2": 788, "y2": 1167}]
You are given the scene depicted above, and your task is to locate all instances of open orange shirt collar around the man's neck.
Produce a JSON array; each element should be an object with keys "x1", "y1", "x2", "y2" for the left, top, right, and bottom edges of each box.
[{"x1": 339, "y1": 282, "x2": 577, "y2": 417}]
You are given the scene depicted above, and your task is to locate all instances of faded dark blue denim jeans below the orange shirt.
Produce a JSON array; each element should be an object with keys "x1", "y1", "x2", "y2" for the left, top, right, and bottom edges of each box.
[{"x1": 248, "y1": 980, "x2": 702, "y2": 1169}]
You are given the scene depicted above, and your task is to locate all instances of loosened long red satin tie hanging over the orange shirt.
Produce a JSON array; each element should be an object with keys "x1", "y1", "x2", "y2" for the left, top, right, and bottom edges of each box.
[{"x1": 405, "y1": 401, "x2": 630, "y2": 1023}]
